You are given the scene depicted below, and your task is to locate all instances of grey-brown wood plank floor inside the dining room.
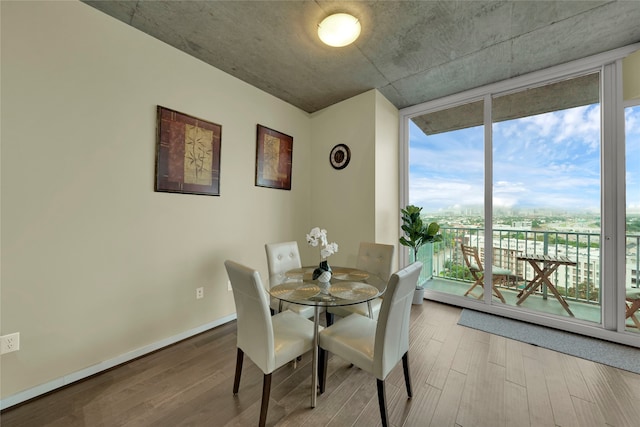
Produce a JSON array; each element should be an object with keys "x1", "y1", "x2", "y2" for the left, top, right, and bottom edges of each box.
[{"x1": 0, "y1": 301, "x2": 640, "y2": 427}]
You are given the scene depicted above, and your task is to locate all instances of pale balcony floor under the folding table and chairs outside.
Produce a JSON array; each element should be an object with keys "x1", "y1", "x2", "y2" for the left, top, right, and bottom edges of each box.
[{"x1": 425, "y1": 278, "x2": 640, "y2": 332}]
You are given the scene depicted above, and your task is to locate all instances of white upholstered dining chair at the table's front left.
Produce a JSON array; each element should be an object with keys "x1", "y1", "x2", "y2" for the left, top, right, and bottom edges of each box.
[{"x1": 224, "y1": 260, "x2": 315, "y2": 427}]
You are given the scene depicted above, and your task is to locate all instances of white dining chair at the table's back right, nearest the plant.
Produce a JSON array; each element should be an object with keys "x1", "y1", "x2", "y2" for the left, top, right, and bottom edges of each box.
[{"x1": 326, "y1": 242, "x2": 395, "y2": 326}]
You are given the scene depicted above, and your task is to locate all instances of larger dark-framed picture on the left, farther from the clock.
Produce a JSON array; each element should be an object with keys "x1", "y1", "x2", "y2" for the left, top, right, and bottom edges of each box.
[{"x1": 155, "y1": 105, "x2": 222, "y2": 196}]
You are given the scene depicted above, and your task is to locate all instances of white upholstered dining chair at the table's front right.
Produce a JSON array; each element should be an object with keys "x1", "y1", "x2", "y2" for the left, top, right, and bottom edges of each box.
[{"x1": 319, "y1": 261, "x2": 422, "y2": 427}]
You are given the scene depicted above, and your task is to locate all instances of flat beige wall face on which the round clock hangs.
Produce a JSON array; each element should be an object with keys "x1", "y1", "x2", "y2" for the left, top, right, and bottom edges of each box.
[{"x1": 310, "y1": 91, "x2": 375, "y2": 265}]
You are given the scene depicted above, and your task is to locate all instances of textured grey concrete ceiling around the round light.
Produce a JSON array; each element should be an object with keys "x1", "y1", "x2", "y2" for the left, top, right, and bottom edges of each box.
[{"x1": 84, "y1": 0, "x2": 640, "y2": 113}]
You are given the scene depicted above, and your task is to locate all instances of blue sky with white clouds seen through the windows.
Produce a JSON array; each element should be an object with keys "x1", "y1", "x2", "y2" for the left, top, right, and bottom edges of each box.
[{"x1": 409, "y1": 105, "x2": 640, "y2": 213}]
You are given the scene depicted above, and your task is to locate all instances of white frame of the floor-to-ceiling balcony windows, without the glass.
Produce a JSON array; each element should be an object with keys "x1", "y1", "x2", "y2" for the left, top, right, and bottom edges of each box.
[{"x1": 399, "y1": 43, "x2": 640, "y2": 346}]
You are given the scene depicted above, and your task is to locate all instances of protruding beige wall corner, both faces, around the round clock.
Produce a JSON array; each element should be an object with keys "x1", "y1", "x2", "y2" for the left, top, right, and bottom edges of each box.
[{"x1": 307, "y1": 90, "x2": 399, "y2": 265}]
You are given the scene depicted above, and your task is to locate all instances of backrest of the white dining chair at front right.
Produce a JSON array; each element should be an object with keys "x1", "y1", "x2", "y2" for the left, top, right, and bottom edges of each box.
[{"x1": 372, "y1": 261, "x2": 422, "y2": 380}]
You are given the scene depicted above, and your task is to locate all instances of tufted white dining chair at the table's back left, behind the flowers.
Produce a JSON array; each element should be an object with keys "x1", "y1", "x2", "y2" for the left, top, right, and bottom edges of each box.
[{"x1": 264, "y1": 241, "x2": 314, "y2": 318}]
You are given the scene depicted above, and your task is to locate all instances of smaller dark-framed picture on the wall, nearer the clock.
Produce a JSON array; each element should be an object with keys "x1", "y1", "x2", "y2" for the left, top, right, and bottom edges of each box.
[{"x1": 256, "y1": 125, "x2": 293, "y2": 190}]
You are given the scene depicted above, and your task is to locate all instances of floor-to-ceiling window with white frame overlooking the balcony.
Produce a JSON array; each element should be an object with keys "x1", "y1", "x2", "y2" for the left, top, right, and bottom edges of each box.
[{"x1": 401, "y1": 46, "x2": 640, "y2": 348}]
